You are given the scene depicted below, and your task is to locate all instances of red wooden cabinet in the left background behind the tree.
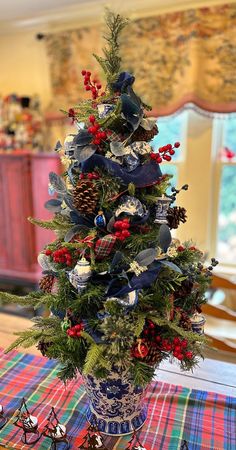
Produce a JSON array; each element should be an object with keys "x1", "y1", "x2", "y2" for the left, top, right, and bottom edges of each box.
[{"x1": 0, "y1": 152, "x2": 60, "y2": 283}]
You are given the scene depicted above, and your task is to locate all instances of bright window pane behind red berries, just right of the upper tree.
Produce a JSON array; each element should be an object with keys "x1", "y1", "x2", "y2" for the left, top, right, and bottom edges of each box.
[{"x1": 150, "y1": 111, "x2": 187, "y2": 161}]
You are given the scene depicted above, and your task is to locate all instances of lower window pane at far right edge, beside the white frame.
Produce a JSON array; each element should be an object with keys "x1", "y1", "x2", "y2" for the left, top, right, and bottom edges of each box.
[{"x1": 217, "y1": 165, "x2": 236, "y2": 264}]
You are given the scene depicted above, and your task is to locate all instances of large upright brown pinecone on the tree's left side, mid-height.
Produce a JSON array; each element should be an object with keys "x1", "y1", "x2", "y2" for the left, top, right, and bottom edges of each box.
[{"x1": 73, "y1": 180, "x2": 98, "y2": 214}]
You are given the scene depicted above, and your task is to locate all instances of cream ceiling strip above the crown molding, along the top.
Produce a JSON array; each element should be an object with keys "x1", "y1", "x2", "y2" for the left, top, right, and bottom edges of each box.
[{"x1": 0, "y1": 0, "x2": 232, "y2": 34}]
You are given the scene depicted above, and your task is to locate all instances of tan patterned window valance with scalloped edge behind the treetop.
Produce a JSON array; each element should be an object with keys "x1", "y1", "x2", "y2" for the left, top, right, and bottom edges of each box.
[{"x1": 46, "y1": 3, "x2": 236, "y2": 115}]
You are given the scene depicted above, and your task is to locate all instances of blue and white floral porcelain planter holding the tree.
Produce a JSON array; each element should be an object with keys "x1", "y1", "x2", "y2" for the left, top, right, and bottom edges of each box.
[{"x1": 84, "y1": 368, "x2": 147, "y2": 436}]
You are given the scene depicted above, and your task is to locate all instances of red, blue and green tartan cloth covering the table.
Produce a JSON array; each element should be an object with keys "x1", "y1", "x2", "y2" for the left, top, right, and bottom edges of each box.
[{"x1": 0, "y1": 351, "x2": 236, "y2": 450}]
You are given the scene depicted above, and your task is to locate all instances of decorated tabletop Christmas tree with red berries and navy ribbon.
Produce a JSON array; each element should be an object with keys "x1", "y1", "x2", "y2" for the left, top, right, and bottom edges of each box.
[{"x1": 2, "y1": 12, "x2": 217, "y2": 434}]
